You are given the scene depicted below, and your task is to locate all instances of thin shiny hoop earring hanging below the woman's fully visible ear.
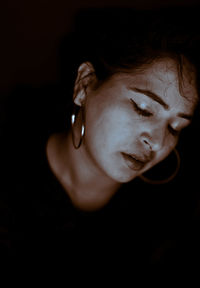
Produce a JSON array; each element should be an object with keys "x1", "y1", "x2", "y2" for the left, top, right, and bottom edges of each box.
[{"x1": 71, "y1": 104, "x2": 85, "y2": 149}]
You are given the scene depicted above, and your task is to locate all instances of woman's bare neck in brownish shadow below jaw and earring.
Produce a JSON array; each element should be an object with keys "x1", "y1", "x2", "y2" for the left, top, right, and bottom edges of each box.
[{"x1": 46, "y1": 133, "x2": 121, "y2": 210}]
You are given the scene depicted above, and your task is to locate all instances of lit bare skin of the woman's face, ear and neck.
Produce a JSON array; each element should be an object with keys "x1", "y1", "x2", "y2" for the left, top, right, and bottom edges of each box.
[{"x1": 47, "y1": 58, "x2": 197, "y2": 210}]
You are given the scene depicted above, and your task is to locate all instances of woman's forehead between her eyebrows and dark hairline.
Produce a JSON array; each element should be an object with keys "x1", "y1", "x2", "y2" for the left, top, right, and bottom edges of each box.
[{"x1": 119, "y1": 58, "x2": 198, "y2": 112}]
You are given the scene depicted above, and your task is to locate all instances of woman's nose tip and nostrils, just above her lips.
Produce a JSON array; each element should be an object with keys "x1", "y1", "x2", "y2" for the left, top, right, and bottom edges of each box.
[{"x1": 141, "y1": 129, "x2": 165, "y2": 152}]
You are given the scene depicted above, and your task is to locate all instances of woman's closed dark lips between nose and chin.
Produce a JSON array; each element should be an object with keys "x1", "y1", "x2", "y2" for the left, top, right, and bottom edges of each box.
[{"x1": 121, "y1": 152, "x2": 150, "y2": 171}]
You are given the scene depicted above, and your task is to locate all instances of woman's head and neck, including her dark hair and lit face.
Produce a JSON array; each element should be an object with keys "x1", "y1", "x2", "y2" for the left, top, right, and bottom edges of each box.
[{"x1": 47, "y1": 7, "x2": 198, "y2": 210}]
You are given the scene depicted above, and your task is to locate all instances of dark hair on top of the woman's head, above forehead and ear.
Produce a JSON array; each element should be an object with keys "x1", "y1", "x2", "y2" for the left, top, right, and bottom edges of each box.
[{"x1": 58, "y1": 7, "x2": 200, "y2": 102}]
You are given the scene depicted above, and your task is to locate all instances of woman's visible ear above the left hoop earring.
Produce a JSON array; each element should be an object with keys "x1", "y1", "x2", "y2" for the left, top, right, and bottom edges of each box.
[{"x1": 73, "y1": 62, "x2": 96, "y2": 106}]
